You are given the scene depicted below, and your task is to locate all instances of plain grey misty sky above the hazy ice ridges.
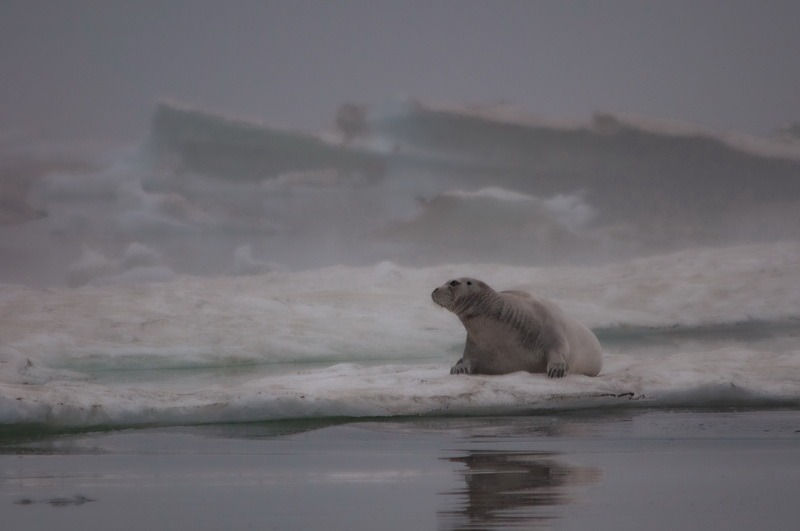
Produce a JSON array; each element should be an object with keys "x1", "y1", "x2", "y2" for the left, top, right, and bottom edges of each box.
[{"x1": 0, "y1": 0, "x2": 800, "y2": 140}]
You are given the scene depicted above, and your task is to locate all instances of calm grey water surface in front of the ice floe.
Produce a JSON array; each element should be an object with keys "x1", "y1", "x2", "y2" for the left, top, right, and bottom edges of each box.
[{"x1": 0, "y1": 410, "x2": 800, "y2": 530}]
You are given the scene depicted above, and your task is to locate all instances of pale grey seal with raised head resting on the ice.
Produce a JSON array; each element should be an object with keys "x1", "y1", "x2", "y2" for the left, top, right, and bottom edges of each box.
[{"x1": 431, "y1": 278, "x2": 603, "y2": 378}]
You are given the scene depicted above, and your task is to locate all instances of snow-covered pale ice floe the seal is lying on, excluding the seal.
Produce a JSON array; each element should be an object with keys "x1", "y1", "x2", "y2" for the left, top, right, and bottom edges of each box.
[{"x1": 0, "y1": 243, "x2": 800, "y2": 426}]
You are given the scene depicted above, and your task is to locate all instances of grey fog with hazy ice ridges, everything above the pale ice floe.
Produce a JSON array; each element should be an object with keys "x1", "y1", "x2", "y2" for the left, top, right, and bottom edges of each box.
[{"x1": 0, "y1": 0, "x2": 800, "y2": 287}]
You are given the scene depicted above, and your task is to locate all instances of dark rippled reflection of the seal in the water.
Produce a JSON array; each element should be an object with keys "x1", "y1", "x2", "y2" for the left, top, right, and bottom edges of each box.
[{"x1": 439, "y1": 451, "x2": 603, "y2": 529}]
